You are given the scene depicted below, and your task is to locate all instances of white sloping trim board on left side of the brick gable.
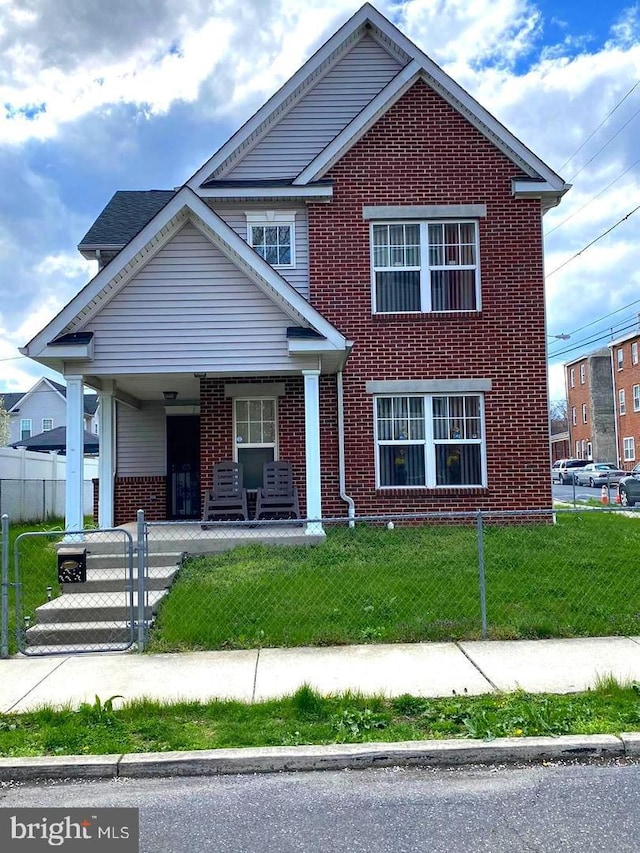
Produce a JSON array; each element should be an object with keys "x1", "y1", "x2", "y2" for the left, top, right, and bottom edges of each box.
[{"x1": 293, "y1": 60, "x2": 421, "y2": 186}]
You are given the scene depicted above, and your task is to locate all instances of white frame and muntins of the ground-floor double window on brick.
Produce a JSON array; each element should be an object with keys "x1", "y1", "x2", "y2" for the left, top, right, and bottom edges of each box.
[{"x1": 373, "y1": 391, "x2": 487, "y2": 492}]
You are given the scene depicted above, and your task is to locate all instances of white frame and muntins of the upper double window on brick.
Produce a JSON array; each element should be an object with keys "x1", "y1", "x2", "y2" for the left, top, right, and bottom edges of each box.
[{"x1": 369, "y1": 219, "x2": 482, "y2": 317}]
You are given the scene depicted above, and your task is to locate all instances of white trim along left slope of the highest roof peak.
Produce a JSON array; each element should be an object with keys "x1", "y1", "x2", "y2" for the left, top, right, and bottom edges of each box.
[{"x1": 185, "y1": 3, "x2": 375, "y2": 193}]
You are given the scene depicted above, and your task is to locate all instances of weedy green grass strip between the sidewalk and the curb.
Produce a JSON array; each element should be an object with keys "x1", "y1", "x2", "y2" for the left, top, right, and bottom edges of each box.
[{"x1": 0, "y1": 678, "x2": 640, "y2": 757}]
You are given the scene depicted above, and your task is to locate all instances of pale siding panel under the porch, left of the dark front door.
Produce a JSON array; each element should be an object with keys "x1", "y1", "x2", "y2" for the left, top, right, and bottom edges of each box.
[{"x1": 116, "y1": 403, "x2": 167, "y2": 477}]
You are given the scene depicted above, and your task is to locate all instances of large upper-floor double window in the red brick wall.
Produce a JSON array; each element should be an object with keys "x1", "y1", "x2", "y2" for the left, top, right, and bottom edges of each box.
[{"x1": 371, "y1": 222, "x2": 480, "y2": 314}]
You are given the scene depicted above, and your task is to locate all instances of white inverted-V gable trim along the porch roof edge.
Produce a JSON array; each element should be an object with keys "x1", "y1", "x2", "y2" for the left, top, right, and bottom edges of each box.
[{"x1": 20, "y1": 187, "x2": 346, "y2": 358}]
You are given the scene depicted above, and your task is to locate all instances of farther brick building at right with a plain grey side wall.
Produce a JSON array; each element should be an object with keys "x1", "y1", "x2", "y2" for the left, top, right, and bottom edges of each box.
[{"x1": 564, "y1": 348, "x2": 618, "y2": 463}]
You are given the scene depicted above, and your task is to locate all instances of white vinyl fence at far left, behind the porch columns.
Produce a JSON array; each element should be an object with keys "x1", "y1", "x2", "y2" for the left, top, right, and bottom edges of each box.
[{"x1": 0, "y1": 447, "x2": 98, "y2": 522}]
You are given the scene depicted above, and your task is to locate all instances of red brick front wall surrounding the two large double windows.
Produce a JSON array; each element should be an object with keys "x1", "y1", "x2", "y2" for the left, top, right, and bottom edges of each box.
[{"x1": 309, "y1": 82, "x2": 551, "y2": 514}]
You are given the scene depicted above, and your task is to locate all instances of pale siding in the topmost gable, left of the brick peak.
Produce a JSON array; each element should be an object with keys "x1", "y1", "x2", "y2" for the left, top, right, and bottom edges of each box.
[{"x1": 222, "y1": 36, "x2": 402, "y2": 180}]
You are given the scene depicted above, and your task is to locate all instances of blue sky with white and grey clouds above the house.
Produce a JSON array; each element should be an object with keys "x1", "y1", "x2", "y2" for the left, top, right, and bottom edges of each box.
[{"x1": 0, "y1": 0, "x2": 640, "y2": 399}]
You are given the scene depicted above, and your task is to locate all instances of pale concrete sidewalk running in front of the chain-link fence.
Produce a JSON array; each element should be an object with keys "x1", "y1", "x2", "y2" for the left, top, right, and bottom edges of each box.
[{"x1": 0, "y1": 637, "x2": 640, "y2": 713}]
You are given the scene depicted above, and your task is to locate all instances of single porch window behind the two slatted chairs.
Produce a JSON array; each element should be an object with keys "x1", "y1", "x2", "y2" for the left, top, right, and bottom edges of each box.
[{"x1": 234, "y1": 397, "x2": 277, "y2": 489}]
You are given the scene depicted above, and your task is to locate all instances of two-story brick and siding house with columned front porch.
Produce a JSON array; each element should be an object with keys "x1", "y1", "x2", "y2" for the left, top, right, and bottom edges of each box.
[{"x1": 22, "y1": 4, "x2": 568, "y2": 528}]
